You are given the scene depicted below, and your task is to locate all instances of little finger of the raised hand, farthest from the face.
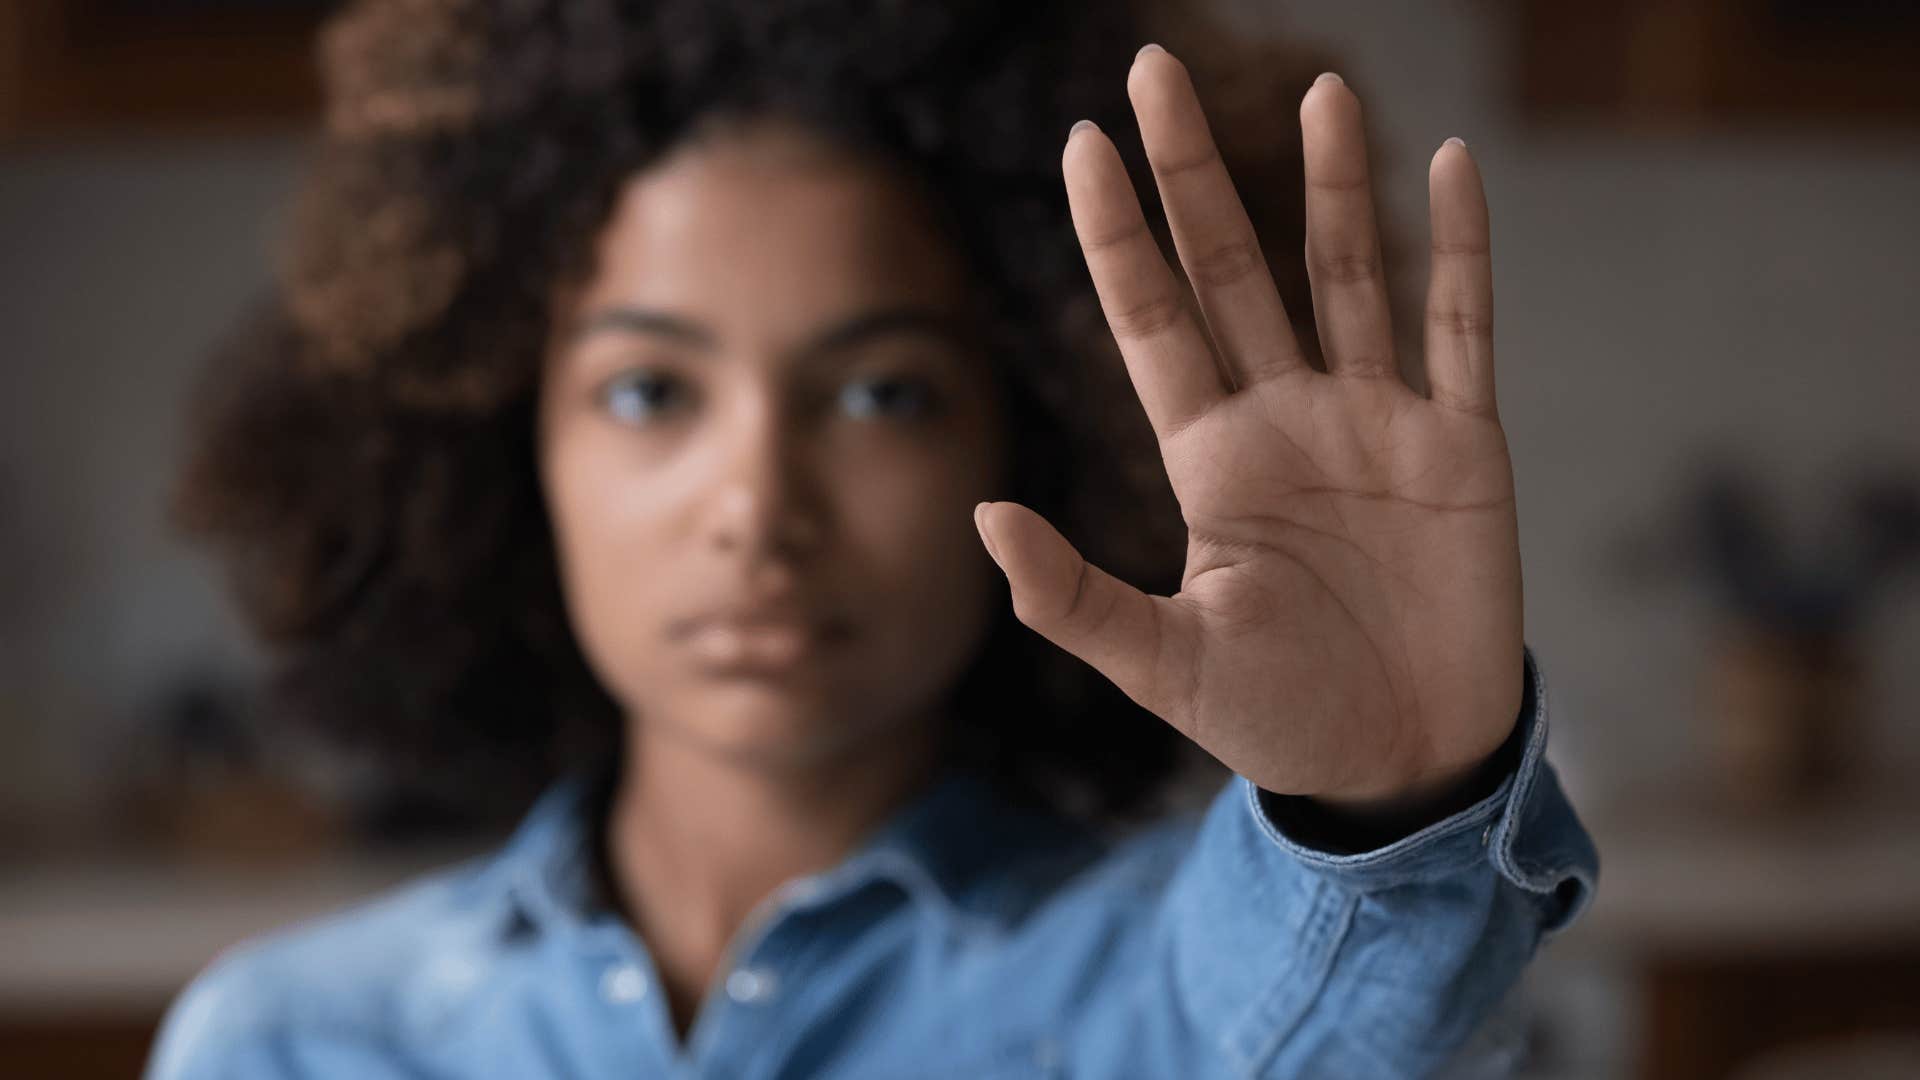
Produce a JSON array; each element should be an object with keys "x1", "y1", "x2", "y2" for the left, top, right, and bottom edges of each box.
[{"x1": 1427, "y1": 138, "x2": 1496, "y2": 417}]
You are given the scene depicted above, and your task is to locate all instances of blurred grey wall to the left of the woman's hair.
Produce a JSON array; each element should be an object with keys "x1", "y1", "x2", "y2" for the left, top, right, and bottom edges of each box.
[{"x1": 0, "y1": 138, "x2": 298, "y2": 824}]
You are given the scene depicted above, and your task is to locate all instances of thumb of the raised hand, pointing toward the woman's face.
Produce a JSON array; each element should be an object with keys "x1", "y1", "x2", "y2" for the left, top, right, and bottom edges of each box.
[{"x1": 973, "y1": 502, "x2": 1187, "y2": 726}]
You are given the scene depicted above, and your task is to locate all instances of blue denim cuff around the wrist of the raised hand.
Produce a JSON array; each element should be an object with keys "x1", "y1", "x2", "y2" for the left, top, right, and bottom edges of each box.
[{"x1": 1236, "y1": 648, "x2": 1599, "y2": 934}]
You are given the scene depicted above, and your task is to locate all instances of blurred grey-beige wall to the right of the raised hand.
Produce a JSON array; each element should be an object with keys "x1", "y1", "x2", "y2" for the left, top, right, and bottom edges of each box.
[{"x1": 1225, "y1": 0, "x2": 1920, "y2": 803}]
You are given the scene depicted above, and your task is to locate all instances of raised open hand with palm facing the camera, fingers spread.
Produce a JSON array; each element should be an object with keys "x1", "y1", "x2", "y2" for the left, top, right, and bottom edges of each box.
[{"x1": 975, "y1": 46, "x2": 1523, "y2": 811}]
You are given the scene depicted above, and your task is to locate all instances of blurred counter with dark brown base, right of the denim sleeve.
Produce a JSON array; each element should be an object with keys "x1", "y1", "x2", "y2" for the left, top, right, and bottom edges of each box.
[{"x1": 1551, "y1": 784, "x2": 1920, "y2": 1080}]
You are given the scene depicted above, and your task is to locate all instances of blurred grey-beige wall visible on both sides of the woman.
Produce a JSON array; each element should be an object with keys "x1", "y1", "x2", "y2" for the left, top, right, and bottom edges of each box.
[{"x1": 0, "y1": 0, "x2": 1920, "y2": 837}]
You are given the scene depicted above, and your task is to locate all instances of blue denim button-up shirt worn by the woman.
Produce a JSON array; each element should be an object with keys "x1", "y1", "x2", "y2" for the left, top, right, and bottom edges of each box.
[{"x1": 148, "y1": 651, "x2": 1597, "y2": 1080}]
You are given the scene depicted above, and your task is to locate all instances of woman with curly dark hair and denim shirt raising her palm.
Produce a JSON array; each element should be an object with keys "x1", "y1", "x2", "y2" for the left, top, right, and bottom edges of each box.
[{"x1": 150, "y1": 0, "x2": 1596, "y2": 1078}]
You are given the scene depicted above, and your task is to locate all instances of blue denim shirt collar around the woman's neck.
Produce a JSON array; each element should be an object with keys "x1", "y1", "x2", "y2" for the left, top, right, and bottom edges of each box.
[{"x1": 497, "y1": 773, "x2": 1092, "y2": 930}]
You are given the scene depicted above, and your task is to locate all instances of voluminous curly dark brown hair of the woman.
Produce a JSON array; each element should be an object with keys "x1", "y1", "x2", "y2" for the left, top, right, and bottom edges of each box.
[{"x1": 173, "y1": 0, "x2": 1323, "y2": 821}]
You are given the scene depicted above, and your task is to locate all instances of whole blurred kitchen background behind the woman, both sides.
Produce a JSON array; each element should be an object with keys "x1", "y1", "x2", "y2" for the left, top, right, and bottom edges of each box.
[{"x1": 0, "y1": 0, "x2": 1920, "y2": 1078}]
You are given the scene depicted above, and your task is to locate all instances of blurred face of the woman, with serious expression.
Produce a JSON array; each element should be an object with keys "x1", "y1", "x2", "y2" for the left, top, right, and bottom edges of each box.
[{"x1": 540, "y1": 123, "x2": 1004, "y2": 765}]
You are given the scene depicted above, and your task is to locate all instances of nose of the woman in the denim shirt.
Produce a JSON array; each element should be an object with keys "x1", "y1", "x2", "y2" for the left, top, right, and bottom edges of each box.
[{"x1": 708, "y1": 396, "x2": 824, "y2": 561}]
